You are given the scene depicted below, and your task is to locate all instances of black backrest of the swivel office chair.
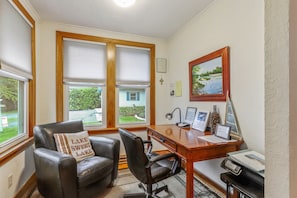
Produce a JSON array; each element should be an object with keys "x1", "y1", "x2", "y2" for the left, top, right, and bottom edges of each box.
[{"x1": 119, "y1": 128, "x2": 149, "y2": 183}]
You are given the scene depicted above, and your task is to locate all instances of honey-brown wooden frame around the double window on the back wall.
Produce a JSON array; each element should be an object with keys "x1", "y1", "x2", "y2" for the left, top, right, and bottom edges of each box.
[{"x1": 56, "y1": 31, "x2": 155, "y2": 132}]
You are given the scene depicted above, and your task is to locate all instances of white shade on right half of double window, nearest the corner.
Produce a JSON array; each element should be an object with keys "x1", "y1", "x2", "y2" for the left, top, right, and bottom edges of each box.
[{"x1": 116, "y1": 46, "x2": 150, "y2": 85}]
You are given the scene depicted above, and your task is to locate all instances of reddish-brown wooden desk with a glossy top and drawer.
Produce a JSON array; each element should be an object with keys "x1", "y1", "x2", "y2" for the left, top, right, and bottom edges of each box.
[{"x1": 147, "y1": 125, "x2": 242, "y2": 198}]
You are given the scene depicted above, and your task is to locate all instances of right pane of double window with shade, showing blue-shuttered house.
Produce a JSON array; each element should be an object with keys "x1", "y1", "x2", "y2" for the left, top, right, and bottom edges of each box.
[{"x1": 116, "y1": 45, "x2": 150, "y2": 125}]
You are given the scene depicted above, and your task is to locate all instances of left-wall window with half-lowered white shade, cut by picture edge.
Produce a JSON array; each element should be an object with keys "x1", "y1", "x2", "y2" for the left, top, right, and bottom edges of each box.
[{"x1": 0, "y1": 0, "x2": 35, "y2": 153}]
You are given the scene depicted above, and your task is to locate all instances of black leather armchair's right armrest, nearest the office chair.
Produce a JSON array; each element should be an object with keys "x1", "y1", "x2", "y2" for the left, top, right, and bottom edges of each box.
[{"x1": 89, "y1": 136, "x2": 120, "y2": 180}]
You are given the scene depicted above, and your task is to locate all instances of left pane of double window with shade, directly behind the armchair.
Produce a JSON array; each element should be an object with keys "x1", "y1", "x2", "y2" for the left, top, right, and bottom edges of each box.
[{"x1": 63, "y1": 39, "x2": 106, "y2": 127}]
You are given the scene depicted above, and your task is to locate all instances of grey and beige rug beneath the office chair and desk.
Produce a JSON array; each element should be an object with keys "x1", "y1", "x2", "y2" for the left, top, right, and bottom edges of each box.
[{"x1": 98, "y1": 169, "x2": 220, "y2": 198}]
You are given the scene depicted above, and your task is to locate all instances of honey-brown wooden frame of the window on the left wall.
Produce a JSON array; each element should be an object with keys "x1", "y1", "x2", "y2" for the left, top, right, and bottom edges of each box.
[{"x1": 0, "y1": 0, "x2": 36, "y2": 165}]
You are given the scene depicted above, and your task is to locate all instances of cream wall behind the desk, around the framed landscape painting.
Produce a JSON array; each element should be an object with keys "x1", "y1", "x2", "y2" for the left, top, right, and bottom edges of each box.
[{"x1": 166, "y1": 0, "x2": 265, "y2": 186}]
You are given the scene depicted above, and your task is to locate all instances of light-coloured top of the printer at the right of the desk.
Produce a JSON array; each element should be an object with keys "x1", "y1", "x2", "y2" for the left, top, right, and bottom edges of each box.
[{"x1": 228, "y1": 150, "x2": 265, "y2": 176}]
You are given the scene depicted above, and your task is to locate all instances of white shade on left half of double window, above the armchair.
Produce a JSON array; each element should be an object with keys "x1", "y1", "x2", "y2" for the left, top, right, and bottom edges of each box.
[{"x1": 64, "y1": 40, "x2": 106, "y2": 84}]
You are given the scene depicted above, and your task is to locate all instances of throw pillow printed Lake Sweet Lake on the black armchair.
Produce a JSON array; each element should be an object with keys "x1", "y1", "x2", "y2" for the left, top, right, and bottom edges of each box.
[{"x1": 54, "y1": 131, "x2": 95, "y2": 161}]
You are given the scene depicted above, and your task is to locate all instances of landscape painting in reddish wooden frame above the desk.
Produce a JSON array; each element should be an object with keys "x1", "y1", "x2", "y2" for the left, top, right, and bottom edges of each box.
[{"x1": 189, "y1": 47, "x2": 230, "y2": 101}]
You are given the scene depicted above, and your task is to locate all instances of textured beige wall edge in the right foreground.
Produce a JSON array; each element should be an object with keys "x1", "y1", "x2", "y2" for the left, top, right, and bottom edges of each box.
[{"x1": 265, "y1": 0, "x2": 297, "y2": 198}]
